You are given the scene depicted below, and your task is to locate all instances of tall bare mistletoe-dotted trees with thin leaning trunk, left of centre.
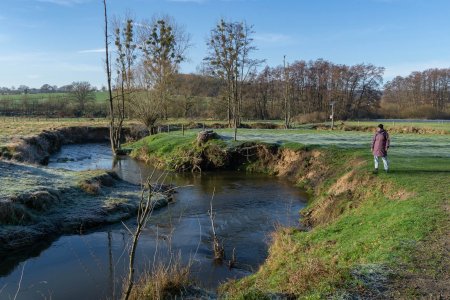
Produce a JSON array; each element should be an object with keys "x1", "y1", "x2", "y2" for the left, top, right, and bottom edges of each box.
[{"x1": 103, "y1": 0, "x2": 189, "y2": 152}]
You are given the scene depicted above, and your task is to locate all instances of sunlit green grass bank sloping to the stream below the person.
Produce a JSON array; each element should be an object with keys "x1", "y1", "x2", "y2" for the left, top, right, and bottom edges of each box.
[{"x1": 222, "y1": 149, "x2": 450, "y2": 299}]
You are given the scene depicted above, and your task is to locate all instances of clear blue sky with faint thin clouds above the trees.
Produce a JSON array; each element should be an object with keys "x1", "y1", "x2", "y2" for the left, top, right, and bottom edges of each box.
[{"x1": 0, "y1": 0, "x2": 450, "y2": 87}]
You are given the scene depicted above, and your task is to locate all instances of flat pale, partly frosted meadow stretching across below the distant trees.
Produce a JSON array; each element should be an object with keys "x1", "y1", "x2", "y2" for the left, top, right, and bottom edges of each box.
[{"x1": 0, "y1": 117, "x2": 450, "y2": 157}]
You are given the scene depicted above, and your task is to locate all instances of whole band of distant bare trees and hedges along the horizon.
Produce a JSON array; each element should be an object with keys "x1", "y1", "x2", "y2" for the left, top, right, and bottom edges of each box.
[{"x1": 0, "y1": 59, "x2": 450, "y2": 122}]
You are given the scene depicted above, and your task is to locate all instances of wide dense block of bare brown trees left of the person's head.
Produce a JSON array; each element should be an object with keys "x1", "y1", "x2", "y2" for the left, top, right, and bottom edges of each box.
[{"x1": 239, "y1": 59, "x2": 384, "y2": 127}]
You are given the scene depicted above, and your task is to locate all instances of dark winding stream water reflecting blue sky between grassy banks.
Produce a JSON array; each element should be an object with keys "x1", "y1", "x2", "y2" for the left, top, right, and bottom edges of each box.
[{"x1": 0, "y1": 144, "x2": 305, "y2": 299}]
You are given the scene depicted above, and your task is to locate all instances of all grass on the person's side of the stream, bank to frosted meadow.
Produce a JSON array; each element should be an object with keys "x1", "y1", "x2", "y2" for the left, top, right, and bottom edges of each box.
[{"x1": 126, "y1": 130, "x2": 450, "y2": 299}]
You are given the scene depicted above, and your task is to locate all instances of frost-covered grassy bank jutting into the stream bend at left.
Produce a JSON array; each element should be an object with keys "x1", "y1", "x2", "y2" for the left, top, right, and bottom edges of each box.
[{"x1": 0, "y1": 160, "x2": 144, "y2": 257}]
